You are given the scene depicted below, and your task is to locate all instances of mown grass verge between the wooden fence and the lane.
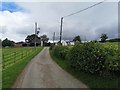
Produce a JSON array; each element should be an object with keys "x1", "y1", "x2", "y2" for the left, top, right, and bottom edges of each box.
[{"x1": 2, "y1": 47, "x2": 43, "y2": 89}]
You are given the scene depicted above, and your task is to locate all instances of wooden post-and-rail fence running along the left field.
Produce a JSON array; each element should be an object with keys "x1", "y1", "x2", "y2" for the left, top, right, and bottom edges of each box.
[{"x1": 2, "y1": 48, "x2": 38, "y2": 70}]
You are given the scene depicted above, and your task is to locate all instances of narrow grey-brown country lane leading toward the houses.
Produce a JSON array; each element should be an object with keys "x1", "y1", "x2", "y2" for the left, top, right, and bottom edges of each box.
[{"x1": 13, "y1": 47, "x2": 87, "y2": 88}]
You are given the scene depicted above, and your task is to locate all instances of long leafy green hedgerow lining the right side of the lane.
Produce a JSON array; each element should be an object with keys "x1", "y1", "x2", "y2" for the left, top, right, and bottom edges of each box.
[{"x1": 52, "y1": 42, "x2": 120, "y2": 77}]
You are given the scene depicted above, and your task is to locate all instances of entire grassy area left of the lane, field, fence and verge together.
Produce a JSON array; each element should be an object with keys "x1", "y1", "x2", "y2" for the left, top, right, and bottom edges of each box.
[{"x1": 2, "y1": 47, "x2": 43, "y2": 88}]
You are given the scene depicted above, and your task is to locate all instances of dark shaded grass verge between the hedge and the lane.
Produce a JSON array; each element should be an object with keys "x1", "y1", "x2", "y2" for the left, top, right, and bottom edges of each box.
[{"x1": 50, "y1": 43, "x2": 120, "y2": 90}]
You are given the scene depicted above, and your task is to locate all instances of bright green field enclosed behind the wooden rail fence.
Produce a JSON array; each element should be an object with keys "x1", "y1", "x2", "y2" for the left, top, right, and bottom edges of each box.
[{"x1": 2, "y1": 47, "x2": 39, "y2": 69}]
